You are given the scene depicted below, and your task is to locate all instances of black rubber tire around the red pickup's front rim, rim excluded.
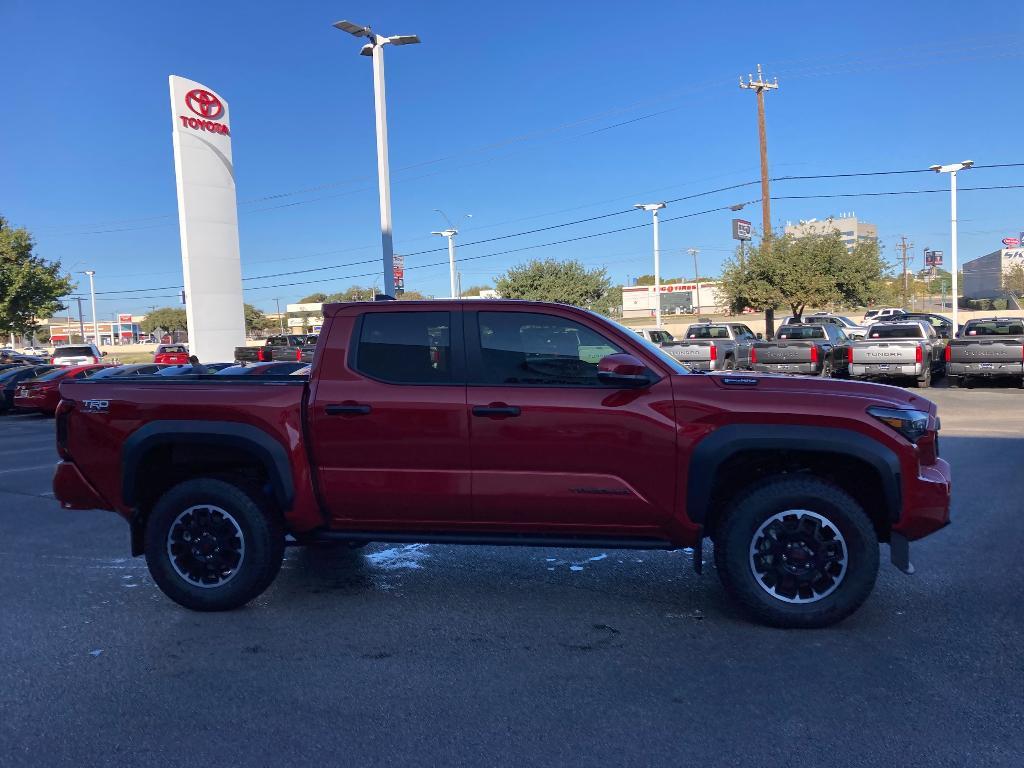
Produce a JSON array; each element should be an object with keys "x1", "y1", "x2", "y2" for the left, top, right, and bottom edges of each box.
[{"x1": 715, "y1": 474, "x2": 879, "y2": 629}]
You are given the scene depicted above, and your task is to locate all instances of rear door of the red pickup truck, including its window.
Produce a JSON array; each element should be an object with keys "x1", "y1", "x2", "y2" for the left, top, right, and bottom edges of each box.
[{"x1": 308, "y1": 303, "x2": 470, "y2": 528}]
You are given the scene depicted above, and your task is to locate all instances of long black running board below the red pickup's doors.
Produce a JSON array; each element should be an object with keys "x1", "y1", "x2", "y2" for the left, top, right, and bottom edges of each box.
[{"x1": 289, "y1": 530, "x2": 679, "y2": 550}]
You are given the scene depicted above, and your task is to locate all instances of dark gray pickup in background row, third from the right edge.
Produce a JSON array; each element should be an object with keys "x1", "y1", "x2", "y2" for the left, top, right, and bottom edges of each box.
[{"x1": 750, "y1": 323, "x2": 850, "y2": 379}]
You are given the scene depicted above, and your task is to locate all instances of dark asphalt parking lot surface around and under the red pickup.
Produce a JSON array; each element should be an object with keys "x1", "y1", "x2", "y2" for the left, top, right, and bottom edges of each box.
[{"x1": 0, "y1": 388, "x2": 1024, "y2": 766}]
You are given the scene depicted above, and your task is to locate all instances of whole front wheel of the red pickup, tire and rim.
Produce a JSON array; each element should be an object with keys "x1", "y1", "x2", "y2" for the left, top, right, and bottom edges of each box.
[{"x1": 715, "y1": 475, "x2": 879, "y2": 628}]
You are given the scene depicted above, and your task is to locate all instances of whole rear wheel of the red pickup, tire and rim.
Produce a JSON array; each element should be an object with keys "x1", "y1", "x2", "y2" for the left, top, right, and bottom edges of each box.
[{"x1": 145, "y1": 478, "x2": 285, "y2": 610}]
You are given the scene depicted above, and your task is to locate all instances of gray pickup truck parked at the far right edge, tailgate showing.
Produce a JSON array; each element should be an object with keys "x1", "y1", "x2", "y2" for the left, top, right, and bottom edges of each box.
[{"x1": 945, "y1": 317, "x2": 1024, "y2": 387}]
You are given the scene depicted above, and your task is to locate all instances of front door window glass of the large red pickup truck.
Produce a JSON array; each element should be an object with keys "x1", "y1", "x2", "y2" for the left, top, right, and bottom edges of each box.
[{"x1": 473, "y1": 312, "x2": 623, "y2": 387}]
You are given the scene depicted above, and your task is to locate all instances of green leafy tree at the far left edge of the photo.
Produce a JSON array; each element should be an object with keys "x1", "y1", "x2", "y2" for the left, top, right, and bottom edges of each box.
[{"x1": 0, "y1": 216, "x2": 75, "y2": 334}]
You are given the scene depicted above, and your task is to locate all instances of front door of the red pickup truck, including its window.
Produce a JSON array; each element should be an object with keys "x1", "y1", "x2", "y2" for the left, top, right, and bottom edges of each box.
[{"x1": 465, "y1": 305, "x2": 676, "y2": 534}]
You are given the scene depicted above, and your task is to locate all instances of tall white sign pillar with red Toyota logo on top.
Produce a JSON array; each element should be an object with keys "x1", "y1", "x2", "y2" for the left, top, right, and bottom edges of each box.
[{"x1": 170, "y1": 75, "x2": 246, "y2": 362}]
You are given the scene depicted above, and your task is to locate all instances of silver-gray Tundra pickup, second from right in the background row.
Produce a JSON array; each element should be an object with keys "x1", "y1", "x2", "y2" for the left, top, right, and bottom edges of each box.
[{"x1": 849, "y1": 319, "x2": 945, "y2": 387}]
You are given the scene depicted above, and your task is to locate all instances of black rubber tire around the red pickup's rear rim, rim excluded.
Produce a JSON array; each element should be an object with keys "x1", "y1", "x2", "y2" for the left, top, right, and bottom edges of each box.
[{"x1": 145, "y1": 478, "x2": 285, "y2": 611}]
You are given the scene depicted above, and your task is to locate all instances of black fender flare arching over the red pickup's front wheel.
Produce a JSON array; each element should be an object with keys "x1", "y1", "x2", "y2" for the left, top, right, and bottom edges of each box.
[{"x1": 686, "y1": 424, "x2": 902, "y2": 524}]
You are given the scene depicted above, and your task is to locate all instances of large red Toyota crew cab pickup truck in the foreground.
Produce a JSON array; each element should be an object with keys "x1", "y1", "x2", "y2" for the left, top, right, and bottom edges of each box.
[{"x1": 53, "y1": 301, "x2": 950, "y2": 627}]
